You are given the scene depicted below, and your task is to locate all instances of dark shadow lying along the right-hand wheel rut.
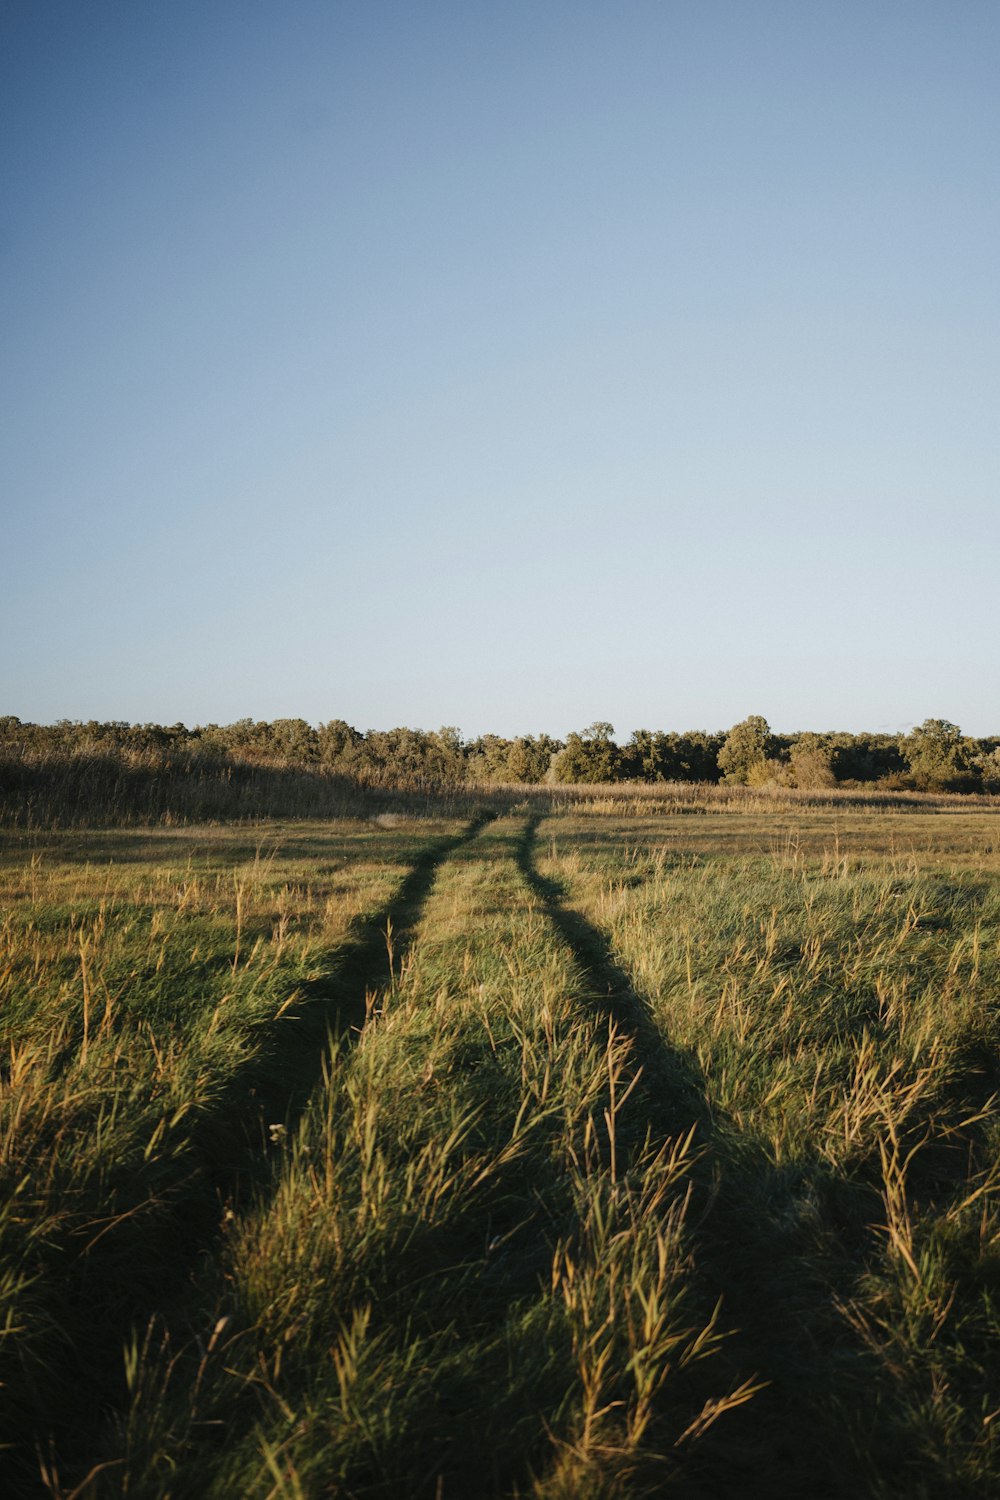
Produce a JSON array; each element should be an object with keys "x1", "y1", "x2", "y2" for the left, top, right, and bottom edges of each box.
[{"x1": 517, "y1": 818, "x2": 879, "y2": 1500}]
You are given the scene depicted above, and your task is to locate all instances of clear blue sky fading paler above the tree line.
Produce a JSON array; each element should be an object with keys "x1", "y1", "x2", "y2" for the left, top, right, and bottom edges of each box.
[{"x1": 0, "y1": 0, "x2": 1000, "y2": 738}]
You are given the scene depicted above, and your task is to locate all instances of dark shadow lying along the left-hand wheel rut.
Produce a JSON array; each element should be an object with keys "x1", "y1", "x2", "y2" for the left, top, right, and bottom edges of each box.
[{"x1": 23, "y1": 812, "x2": 495, "y2": 1496}]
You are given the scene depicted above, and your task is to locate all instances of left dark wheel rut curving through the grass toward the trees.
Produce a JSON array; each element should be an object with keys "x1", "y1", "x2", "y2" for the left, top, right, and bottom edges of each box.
[{"x1": 37, "y1": 812, "x2": 496, "y2": 1494}]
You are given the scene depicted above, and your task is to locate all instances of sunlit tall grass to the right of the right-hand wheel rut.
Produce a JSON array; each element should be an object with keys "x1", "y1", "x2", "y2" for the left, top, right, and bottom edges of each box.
[{"x1": 540, "y1": 824, "x2": 1000, "y2": 1496}]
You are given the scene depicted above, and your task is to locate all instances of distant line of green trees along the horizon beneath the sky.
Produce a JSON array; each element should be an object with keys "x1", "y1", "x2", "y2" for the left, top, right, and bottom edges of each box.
[{"x1": 0, "y1": 714, "x2": 1000, "y2": 792}]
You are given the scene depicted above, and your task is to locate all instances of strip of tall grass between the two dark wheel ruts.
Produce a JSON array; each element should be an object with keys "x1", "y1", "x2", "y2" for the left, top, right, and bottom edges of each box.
[{"x1": 27, "y1": 822, "x2": 740, "y2": 1496}]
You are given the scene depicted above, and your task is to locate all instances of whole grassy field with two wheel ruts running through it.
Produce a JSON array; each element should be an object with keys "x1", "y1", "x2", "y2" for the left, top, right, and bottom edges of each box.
[{"x1": 0, "y1": 789, "x2": 1000, "y2": 1500}]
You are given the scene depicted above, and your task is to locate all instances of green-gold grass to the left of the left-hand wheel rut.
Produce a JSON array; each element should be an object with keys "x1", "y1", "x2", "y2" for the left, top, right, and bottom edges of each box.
[{"x1": 0, "y1": 825, "x2": 464, "y2": 1488}]
